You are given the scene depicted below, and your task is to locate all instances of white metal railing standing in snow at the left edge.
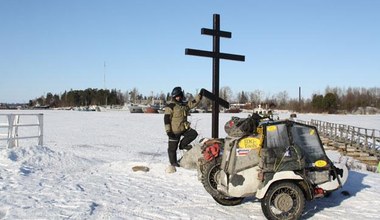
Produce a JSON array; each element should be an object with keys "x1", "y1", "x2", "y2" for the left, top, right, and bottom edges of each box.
[{"x1": 0, "y1": 114, "x2": 44, "y2": 148}]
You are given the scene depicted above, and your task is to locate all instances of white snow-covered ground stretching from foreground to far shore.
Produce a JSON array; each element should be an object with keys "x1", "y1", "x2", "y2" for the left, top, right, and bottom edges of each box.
[{"x1": 0, "y1": 110, "x2": 380, "y2": 220}]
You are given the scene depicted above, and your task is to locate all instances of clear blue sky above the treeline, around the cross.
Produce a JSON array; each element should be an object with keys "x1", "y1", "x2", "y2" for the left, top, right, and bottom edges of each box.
[{"x1": 0, "y1": 0, "x2": 380, "y2": 103}]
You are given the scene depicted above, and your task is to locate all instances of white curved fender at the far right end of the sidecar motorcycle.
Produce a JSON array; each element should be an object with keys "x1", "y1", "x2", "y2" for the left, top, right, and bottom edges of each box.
[{"x1": 318, "y1": 163, "x2": 348, "y2": 191}]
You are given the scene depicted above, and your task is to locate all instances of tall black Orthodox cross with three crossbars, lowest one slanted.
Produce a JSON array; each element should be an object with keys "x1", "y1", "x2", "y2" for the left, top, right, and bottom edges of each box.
[{"x1": 185, "y1": 14, "x2": 245, "y2": 138}]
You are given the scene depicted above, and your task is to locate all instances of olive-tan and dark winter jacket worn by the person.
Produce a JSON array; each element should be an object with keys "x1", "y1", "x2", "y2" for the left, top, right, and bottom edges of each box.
[{"x1": 164, "y1": 95, "x2": 202, "y2": 134}]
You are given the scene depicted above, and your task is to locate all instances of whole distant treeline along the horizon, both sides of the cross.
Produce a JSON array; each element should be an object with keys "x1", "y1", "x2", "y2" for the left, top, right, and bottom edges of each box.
[{"x1": 29, "y1": 87, "x2": 380, "y2": 113}]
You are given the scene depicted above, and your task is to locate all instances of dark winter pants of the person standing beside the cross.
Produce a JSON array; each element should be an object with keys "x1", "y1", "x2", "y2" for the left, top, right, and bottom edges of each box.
[{"x1": 168, "y1": 128, "x2": 198, "y2": 165}]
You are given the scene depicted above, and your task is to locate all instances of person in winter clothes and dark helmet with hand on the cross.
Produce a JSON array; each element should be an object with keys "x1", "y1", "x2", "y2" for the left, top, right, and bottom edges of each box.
[{"x1": 164, "y1": 87, "x2": 203, "y2": 167}]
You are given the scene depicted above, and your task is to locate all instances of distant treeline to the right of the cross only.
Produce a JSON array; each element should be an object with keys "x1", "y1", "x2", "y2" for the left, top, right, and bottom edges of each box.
[{"x1": 220, "y1": 87, "x2": 380, "y2": 113}]
